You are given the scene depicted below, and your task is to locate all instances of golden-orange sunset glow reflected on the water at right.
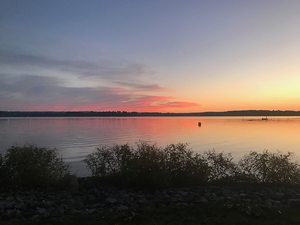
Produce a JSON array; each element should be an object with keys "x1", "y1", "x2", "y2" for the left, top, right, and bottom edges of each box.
[{"x1": 186, "y1": 118, "x2": 300, "y2": 157}]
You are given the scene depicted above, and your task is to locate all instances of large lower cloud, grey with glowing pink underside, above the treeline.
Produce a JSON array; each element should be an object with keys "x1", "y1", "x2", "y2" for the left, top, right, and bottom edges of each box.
[{"x1": 0, "y1": 74, "x2": 199, "y2": 111}]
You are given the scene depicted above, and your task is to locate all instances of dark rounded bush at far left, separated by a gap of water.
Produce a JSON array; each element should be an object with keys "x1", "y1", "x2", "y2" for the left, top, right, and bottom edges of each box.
[{"x1": 0, "y1": 145, "x2": 69, "y2": 187}]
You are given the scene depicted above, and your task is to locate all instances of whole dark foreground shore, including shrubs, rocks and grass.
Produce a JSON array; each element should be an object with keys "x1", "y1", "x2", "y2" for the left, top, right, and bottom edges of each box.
[{"x1": 0, "y1": 142, "x2": 300, "y2": 224}]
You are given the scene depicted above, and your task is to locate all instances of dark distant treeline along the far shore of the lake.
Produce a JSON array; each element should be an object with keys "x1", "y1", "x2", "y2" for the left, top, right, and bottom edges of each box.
[{"x1": 0, "y1": 110, "x2": 300, "y2": 117}]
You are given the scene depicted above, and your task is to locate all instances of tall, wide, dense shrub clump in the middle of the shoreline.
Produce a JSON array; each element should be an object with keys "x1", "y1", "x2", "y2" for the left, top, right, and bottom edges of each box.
[{"x1": 84, "y1": 142, "x2": 209, "y2": 188}]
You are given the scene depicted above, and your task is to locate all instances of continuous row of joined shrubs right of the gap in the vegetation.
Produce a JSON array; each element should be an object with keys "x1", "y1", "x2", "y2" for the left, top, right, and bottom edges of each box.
[{"x1": 84, "y1": 142, "x2": 300, "y2": 188}]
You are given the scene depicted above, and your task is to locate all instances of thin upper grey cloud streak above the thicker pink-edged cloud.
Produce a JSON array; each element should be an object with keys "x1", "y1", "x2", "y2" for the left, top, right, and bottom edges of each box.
[{"x1": 0, "y1": 51, "x2": 153, "y2": 79}]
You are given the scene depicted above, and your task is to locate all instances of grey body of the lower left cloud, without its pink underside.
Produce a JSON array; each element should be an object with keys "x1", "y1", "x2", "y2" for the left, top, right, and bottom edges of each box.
[{"x1": 0, "y1": 75, "x2": 129, "y2": 108}]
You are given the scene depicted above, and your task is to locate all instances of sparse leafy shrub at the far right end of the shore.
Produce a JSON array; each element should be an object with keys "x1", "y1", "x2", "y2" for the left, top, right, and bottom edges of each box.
[{"x1": 238, "y1": 150, "x2": 300, "y2": 184}]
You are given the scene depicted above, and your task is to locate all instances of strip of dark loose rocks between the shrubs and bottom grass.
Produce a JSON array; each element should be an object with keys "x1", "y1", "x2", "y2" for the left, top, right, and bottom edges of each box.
[{"x1": 0, "y1": 177, "x2": 300, "y2": 221}]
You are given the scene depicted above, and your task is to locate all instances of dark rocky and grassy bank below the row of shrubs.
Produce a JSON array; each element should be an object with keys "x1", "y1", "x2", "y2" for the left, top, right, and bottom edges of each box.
[{"x1": 0, "y1": 177, "x2": 300, "y2": 225}]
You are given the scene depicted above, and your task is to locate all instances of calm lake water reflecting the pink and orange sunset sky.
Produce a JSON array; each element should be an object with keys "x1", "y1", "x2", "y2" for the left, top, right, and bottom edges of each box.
[{"x1": 0, "y1": 117, "x2": 300, "y2": 176}]
